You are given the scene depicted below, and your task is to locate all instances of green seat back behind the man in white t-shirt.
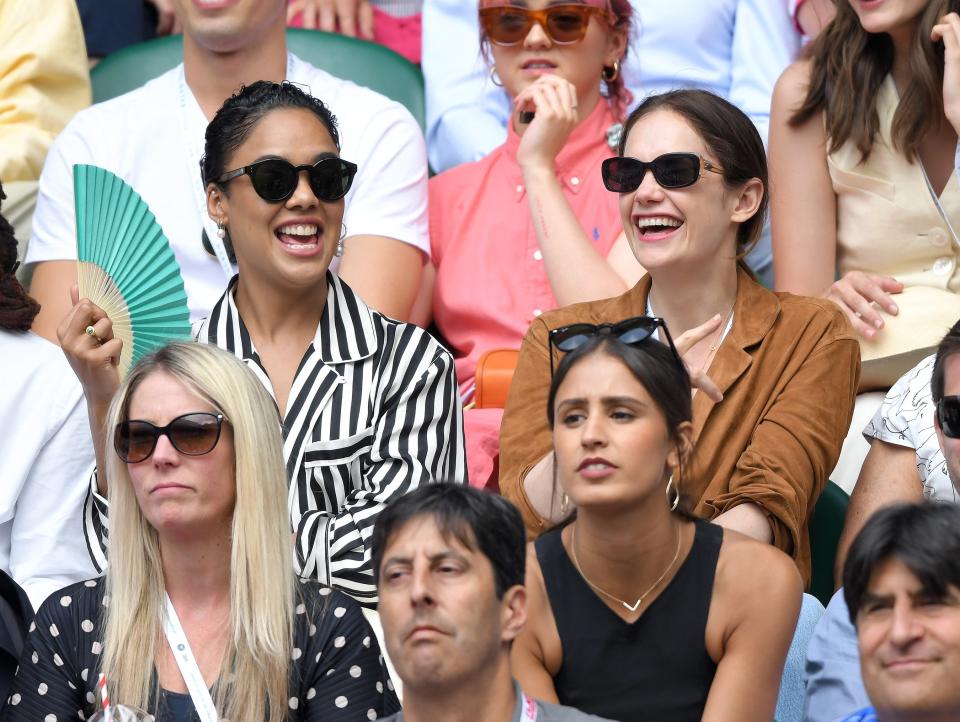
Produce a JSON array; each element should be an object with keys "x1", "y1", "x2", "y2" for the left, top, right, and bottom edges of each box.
[{"x1": 90, "y1": 28, "x2": 426, "y2": 130}]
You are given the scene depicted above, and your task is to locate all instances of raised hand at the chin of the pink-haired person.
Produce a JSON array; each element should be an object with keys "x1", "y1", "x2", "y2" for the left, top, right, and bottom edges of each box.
[{"x1": 513, "y1": 74, "x2": 579, "y2": 173}]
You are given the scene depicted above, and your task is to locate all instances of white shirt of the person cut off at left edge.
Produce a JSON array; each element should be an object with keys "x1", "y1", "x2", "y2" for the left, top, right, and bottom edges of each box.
[{"x1": 0, "y1": 330, "x2": 97, "y2": 608}]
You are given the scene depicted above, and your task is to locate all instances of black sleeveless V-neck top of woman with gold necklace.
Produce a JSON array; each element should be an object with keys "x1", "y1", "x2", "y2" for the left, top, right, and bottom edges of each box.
[{"x1": 534, "y1": 520, "x2": 723, "y2": 722}]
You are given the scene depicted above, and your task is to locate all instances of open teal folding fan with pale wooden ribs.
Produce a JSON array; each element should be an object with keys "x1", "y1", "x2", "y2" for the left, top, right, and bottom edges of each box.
[{"x1": 73, "y1": 165, "x2": 190, "y2": 378}]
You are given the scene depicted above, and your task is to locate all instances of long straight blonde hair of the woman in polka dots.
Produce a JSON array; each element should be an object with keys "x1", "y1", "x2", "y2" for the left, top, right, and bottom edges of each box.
[{"x1": 103, "y1": 343, "x2": 295, "y2": 722}]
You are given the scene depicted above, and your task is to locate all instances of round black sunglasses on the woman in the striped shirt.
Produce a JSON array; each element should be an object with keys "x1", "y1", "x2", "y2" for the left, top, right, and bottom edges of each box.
[{"x1": 216, "y1": 158, "x2": 357, "y2": 203}]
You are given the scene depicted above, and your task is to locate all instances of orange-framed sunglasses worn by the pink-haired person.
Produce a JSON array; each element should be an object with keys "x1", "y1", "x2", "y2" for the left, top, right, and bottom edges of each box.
[{"x1": 480, "y1": 3, "x2": 610, "y2": 47}]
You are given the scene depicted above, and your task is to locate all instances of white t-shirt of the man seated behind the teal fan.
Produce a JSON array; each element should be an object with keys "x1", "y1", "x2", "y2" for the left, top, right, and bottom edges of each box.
[{"x1": 26, "y1": 54, "x2": 430, "y2": 320}]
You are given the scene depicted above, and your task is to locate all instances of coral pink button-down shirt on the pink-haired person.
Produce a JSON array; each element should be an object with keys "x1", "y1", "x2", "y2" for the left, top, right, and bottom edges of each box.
[{"x1": 430, "y1": 101, "x2": 622, "y2": 394}]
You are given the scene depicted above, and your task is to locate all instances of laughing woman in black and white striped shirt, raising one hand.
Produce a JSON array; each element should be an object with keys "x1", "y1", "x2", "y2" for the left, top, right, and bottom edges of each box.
[{"x1": 60, "y1": 82, "x2": 466, "y2": 604}]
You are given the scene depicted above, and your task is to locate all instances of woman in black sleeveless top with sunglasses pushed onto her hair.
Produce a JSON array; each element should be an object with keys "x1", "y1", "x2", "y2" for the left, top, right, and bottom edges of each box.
[{"x1": 512, "y1": 330, "x2": 802, "y2": 722}]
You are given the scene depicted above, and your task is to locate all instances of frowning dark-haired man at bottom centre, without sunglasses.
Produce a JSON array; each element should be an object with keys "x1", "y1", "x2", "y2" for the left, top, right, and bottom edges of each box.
[{"x1": 373, "y1": 484, "x2": 600, "y2": 722}]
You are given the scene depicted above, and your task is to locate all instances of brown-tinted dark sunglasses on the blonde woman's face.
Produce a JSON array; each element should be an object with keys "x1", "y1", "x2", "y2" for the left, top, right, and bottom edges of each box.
[{"x1": 113, "y1": 412, "x2": 223, "y2": 464}]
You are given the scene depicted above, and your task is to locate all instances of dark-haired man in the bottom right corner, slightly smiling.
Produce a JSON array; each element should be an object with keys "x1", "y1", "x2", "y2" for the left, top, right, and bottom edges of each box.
[{"x1": 843, "y1": 502, "x2": 960, "y2": 722}]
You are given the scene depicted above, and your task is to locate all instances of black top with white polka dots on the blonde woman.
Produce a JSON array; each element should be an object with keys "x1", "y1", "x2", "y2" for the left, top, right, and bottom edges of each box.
[{"x1": 2, "y1": 579, "x2": 400, "y2": 722}]
